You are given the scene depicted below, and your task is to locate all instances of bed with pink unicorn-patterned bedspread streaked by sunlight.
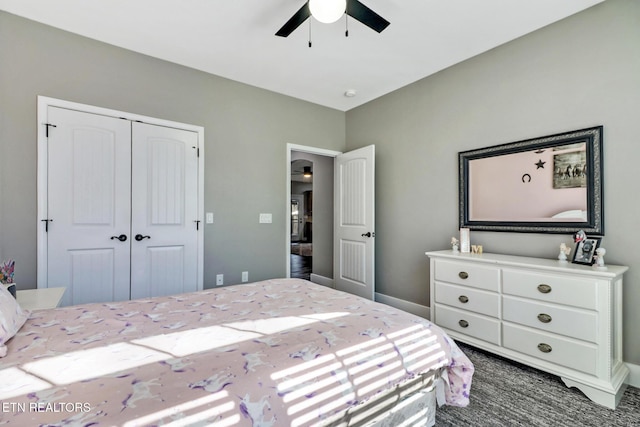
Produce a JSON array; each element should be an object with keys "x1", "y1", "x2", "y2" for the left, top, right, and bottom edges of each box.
[{"x1": 0, "y1": 279, "x2": 473, "y2": 427}]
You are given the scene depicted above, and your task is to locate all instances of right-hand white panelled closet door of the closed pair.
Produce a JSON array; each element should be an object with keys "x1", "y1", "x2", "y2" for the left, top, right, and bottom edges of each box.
[{"x1": 131, "y1": 122, "x2": 202, "y2": 298}]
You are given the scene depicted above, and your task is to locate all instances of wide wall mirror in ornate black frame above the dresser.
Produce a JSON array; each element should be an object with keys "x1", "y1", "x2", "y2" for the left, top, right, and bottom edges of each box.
[{"x1": 458, "y1": 126, "x2": 604, "y2": 236}]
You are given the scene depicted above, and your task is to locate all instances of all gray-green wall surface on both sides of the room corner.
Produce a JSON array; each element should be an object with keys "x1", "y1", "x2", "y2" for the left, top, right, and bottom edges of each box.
[{"x1": 0, "y1": 0, "x2": 640, "y2": 363}]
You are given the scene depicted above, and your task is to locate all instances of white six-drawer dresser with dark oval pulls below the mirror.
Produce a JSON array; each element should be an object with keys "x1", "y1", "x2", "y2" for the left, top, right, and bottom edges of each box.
[{"x1": 427, "y1": 250, "x2": 629, "y2": 408}]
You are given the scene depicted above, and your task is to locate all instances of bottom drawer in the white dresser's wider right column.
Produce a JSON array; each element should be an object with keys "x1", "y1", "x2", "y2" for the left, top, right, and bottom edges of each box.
[{"x1": 502, "y1": 323, "x2": 597, "y2": 375}]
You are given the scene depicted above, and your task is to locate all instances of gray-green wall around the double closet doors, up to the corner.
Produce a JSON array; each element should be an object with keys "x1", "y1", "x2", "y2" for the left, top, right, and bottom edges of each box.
[{"x1": 0, "y1": 12, "x2": 345, "y2": 289}]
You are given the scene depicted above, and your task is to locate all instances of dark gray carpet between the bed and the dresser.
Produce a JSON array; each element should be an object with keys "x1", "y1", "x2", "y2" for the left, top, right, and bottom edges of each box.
[{"x1": 436, "y1": 344, "x2": 640, "y2": 427}]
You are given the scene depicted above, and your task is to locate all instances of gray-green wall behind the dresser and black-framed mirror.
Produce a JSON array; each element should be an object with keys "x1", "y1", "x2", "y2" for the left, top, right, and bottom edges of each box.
[{"x1": 347, "y1": 0, "x2": 640, "y2": 364}]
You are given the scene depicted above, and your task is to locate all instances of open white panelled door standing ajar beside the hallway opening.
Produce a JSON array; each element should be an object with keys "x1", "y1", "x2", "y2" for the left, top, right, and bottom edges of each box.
[{"x1": 333, "y1": 145, "x2": 375, "y2": 300}]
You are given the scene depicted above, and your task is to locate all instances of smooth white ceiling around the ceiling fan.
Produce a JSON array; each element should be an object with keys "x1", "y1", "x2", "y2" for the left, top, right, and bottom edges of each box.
[{"x1": 0, "y1": 0, "x2": 604, "y2": 111}]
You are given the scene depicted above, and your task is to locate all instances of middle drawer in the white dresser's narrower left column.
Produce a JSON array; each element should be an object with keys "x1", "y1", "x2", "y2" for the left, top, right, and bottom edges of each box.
[{"x1": 436, "y1": 282, "x2": 500, "y2": 318}]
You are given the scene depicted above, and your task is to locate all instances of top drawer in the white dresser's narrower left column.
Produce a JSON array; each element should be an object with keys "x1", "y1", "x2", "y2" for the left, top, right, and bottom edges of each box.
[{"x1": 435, "y1": 260, "x2": 500, "y2": 292}]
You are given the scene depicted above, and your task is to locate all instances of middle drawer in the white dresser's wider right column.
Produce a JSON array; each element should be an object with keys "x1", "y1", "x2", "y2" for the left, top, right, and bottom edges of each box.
[{"x1": 502, "y1": 295, "x2": 597, "y2": 343}]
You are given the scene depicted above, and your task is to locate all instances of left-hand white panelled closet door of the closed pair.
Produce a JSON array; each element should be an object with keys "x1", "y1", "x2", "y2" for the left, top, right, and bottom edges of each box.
[{"x1": 47, "y1": 107, "x2": 131, "y2": 305}]
